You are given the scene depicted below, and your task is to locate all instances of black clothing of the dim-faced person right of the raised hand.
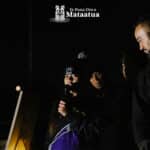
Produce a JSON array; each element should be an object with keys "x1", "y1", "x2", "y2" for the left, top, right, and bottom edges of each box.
[{"x1": 74, "y1": 86, "x2": 109, "y2": 150}]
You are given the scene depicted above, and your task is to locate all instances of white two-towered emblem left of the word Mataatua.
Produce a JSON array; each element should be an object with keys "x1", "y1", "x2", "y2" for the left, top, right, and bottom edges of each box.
[{"x1": 51, "y1": 5, "x2": 69, "y2": 23}]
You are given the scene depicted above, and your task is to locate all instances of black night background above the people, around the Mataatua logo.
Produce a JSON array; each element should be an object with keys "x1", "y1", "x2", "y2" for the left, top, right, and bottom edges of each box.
[{"x1": 0, "y1": 0, "x2": 149, "y2": 138}]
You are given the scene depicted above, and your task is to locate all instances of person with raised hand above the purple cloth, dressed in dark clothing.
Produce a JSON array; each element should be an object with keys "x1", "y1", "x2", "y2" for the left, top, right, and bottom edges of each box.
[{"x1": 45, "y1": 53, "x2": 86, "y2": 149}]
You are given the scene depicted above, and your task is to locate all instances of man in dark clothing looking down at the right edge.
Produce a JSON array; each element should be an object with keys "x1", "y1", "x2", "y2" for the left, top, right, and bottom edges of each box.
[{"x1": 132, "y1": 15, "x2": 150, "y2": 150}]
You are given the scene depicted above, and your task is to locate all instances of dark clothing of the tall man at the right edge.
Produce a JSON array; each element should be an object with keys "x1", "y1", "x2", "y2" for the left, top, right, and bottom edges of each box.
[{"x1": 132, "y1": 60, "x2": 150, "y2": 150}]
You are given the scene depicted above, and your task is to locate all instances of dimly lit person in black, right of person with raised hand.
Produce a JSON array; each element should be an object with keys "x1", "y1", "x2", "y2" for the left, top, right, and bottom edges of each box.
[{"x1": 75, "y1": 64, "x2": 107, "y2": 150}]
